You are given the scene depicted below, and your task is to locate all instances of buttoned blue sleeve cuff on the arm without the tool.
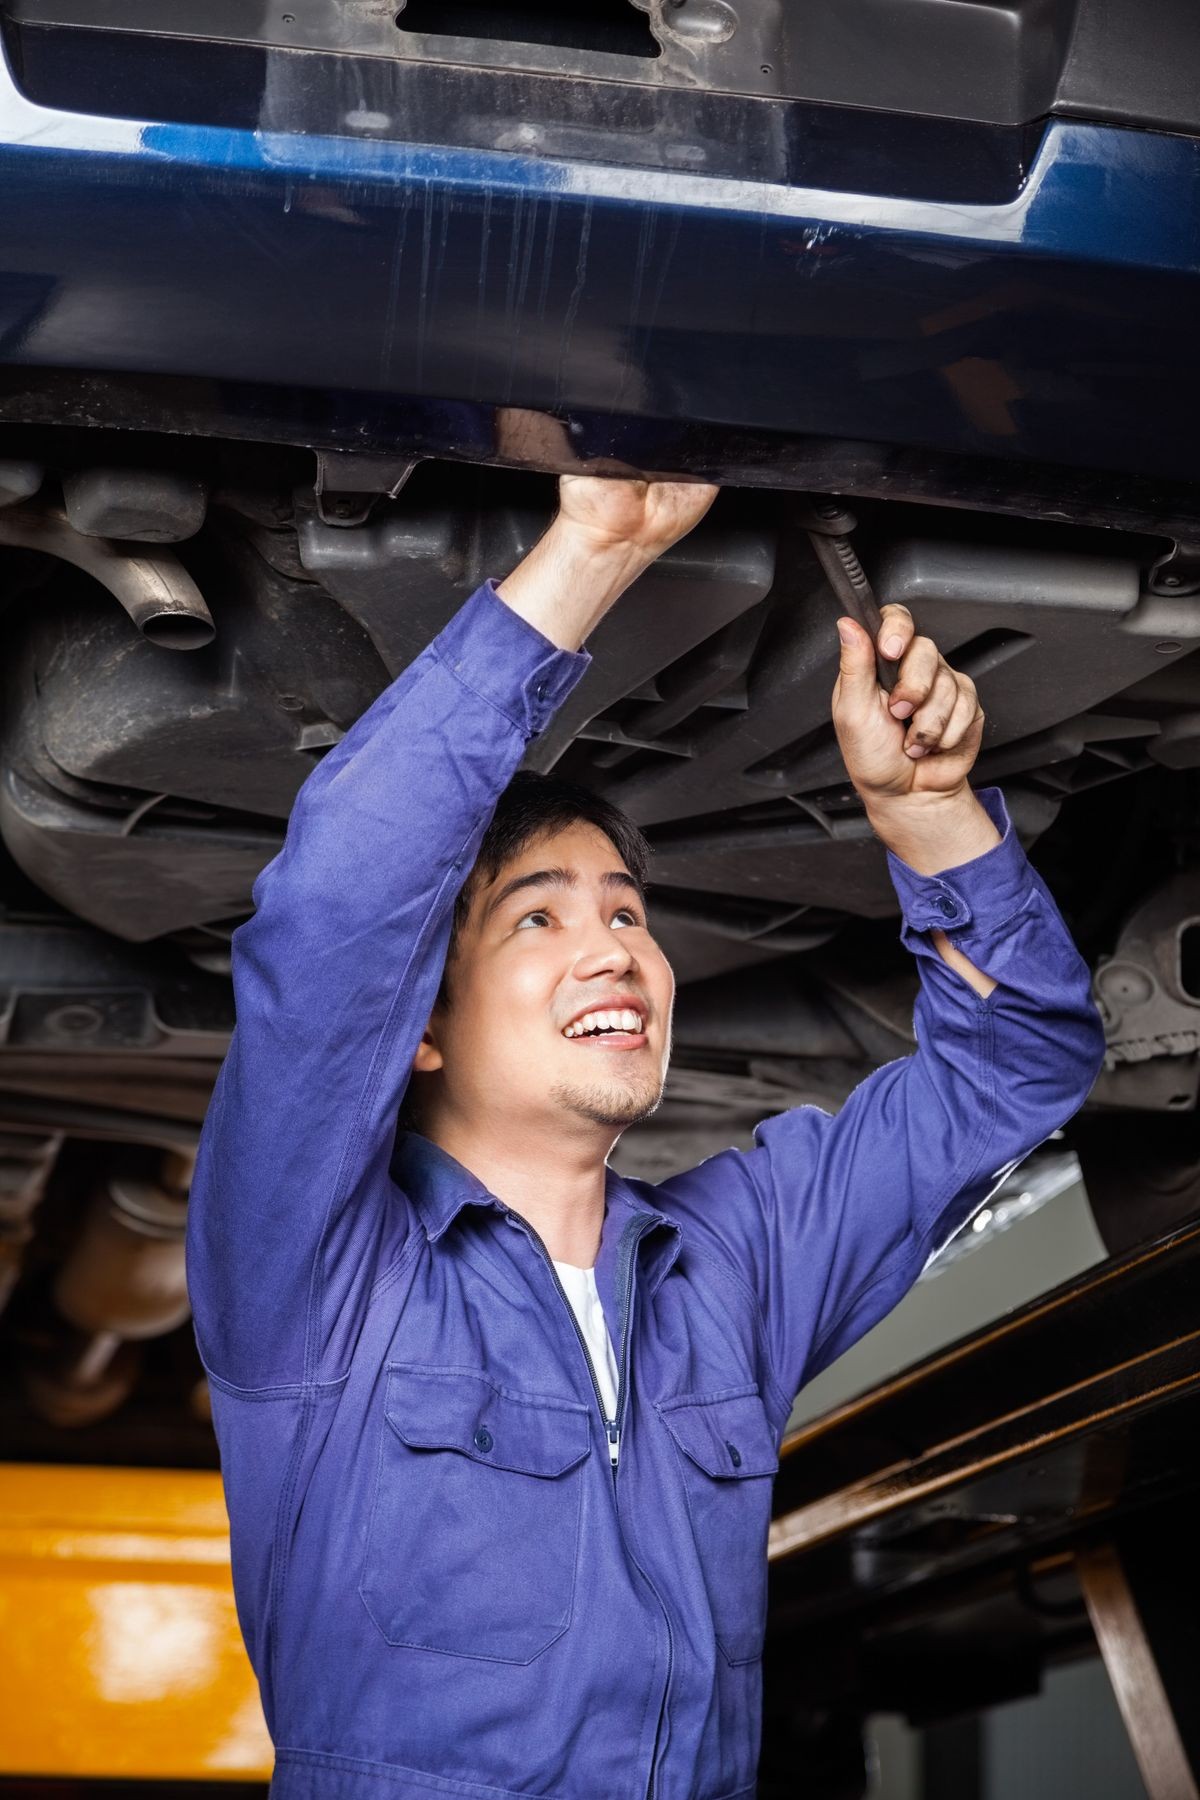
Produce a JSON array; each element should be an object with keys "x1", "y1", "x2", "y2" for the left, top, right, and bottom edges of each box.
[{"x1": 430, "y1": 580, "x2": 592, "y2": 738}]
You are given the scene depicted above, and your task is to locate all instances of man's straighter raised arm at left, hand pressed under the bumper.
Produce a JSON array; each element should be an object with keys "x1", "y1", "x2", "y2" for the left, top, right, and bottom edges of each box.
[{"x1": 189, "y1": 481, "x2": 714, "y2": 1390}]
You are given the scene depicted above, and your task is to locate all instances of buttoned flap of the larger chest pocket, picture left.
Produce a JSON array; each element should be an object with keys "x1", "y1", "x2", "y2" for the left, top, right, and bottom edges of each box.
[{"x1": 385, "y1": 1364, "x2": 592, "y2": 1476}]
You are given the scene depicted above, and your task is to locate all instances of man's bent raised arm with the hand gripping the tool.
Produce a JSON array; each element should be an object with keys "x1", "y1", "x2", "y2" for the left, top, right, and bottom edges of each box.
[{"x1": 662, "y1": 608, "x2": 1103, "y2": 1408}]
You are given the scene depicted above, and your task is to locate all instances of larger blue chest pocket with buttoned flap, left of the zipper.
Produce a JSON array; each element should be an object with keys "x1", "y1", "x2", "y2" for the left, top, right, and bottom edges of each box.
[{"x1": 360, "y1": 1363, "x2": 590, "y2": 1663}]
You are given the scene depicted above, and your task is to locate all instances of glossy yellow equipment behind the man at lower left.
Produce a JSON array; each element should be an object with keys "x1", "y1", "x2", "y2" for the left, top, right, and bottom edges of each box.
[{"x1": 0, "y1": 1463, "x2": 272, "y2": 1780}]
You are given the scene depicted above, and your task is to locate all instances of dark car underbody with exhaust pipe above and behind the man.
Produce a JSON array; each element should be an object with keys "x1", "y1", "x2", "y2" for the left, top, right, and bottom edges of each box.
[{"x1": 0, "y1": 414, "x2": 1200, "y2": 1411}]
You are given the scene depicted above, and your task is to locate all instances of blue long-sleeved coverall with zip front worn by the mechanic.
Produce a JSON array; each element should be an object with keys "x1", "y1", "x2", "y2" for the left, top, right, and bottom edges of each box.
[{"x1": 189, "y1": 583, "x2": 1101, "y2": 1800}]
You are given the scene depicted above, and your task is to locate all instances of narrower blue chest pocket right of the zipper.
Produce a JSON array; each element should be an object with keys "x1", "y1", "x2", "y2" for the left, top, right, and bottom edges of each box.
[{"x1": 657, "y1": 1388, "x2": 779, "y2": 1663}]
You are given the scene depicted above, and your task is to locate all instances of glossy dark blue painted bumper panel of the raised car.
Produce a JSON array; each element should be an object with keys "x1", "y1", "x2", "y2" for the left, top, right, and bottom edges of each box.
[{"x1": 0, "y1": 41, "x2": 1200, "y2": 479}]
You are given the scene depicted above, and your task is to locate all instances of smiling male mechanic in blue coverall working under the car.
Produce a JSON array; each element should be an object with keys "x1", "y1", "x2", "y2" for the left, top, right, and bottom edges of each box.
[{"x1": 189, "y1": 477, "x2": 1103, "y2": 1800}]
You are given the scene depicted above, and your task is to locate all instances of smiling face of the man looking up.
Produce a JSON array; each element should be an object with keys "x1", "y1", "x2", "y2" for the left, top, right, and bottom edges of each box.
[{"x1": 416, "y1": 823, "x2": 675, "y2": 1130}]
